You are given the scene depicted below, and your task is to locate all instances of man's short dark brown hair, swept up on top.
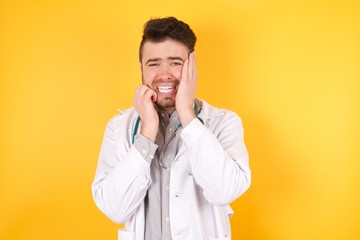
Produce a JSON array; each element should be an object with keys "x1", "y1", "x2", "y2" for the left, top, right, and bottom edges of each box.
[{"x1": 139, "y1": 17, "x2": 196, "y2": 62}]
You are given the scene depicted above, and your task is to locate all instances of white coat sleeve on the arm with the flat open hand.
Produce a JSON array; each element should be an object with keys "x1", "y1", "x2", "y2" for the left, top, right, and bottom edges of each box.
[{"x1": 181, "y1": 112, "x2": 251, "y2": 206}]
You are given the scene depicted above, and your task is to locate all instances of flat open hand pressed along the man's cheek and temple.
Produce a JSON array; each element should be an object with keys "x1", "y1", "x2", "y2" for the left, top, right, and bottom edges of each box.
[{"x1": 176, "y1": 52, "x2": 197, "y2": 127}]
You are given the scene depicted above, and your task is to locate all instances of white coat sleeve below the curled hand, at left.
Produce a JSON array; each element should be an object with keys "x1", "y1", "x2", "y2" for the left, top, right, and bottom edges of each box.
[{"x1": 92, "y1": 117, "x2": 151, "y2": 223}]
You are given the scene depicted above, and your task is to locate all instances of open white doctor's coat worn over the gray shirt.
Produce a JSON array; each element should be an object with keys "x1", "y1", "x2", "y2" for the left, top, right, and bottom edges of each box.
[{"x1": 92, "y1": 101, "x2": 251, "y2": 240}]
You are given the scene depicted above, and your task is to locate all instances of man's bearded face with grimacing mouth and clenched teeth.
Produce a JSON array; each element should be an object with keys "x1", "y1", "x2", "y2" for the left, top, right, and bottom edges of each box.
[{"x1": 141, "y1": 39, "x2": 189, "y2": 112}]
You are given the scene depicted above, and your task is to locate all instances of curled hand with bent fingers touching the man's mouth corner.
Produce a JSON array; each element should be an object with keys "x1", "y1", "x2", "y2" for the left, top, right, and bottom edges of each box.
[{"x1": 133, "y1": 85, "x2": 159, "y2": 142}]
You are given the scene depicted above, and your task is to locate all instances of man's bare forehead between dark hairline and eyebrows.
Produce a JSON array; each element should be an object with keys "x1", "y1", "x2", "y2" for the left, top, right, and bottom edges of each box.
[{"x1": 142, "y1": 39, "x2": 189, "y2": 61}]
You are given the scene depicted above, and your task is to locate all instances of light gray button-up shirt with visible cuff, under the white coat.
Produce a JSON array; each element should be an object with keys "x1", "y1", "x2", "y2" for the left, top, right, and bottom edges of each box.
[{"x1": 135, "y1": 111, "x2": 182, "y2": 240}]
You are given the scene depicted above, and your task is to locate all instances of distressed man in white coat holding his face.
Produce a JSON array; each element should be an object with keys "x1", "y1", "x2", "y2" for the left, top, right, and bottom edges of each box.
[{"x1": 92, "y1": 17, "x2": 251, "y2": 240}]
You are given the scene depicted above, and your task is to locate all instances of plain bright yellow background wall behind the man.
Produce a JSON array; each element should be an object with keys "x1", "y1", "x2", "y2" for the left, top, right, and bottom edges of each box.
[{"x1": 0, "y1": 0, "x2": 360, "y2": 240}]
